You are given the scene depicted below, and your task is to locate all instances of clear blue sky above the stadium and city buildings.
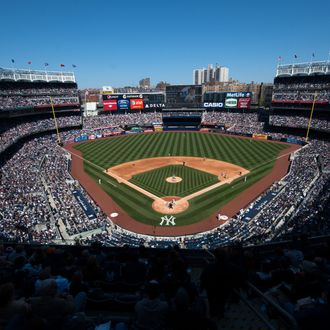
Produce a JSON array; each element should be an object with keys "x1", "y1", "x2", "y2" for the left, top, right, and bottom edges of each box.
[{"x1": 0, "y1": 0, "x2": 330, "y2": 88}]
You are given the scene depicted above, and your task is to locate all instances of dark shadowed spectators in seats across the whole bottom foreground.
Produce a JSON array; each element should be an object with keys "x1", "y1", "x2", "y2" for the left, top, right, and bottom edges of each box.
[{"x1": 0, "y1": 237, "x2": 330, "y2": 330}]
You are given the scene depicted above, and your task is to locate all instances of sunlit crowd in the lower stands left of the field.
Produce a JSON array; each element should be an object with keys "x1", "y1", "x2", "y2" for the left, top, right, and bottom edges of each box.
[{"x1": 0, "y1": 135, "x2": 106, "y2": 242}]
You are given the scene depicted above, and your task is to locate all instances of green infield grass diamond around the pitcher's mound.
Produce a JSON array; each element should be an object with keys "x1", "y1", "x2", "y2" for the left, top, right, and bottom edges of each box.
[{"x1": 129, "y1": 165, "x2": 219, "y2": 197}]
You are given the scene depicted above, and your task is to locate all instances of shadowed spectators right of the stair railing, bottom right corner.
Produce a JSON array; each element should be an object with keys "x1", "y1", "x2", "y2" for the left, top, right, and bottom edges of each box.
[{"x1": 246, "y1": 236, "x2": 330, "y2": 330}]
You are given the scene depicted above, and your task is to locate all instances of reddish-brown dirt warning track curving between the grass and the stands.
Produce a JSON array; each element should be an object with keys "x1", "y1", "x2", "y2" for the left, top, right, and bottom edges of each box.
[{"x1": 65, "y1": 133, "x2": 300, "y2": 236}]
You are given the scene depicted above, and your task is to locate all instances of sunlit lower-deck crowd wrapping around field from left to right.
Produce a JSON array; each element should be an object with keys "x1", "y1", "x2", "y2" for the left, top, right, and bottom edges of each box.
[{"x1": 0, "y1": 113, "x2": 330, "y2": 248}]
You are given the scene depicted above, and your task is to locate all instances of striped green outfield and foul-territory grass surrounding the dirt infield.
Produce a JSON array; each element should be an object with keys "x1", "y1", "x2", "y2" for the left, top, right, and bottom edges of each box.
[{"x1": 75, "y1": 132, "x2": 287, "y2": 225}]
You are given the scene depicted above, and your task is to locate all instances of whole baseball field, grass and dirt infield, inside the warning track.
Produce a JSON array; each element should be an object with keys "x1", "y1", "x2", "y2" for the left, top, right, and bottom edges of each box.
[{"x1": 71, "y1": 132, "x2": 288, "y2": 226}]
